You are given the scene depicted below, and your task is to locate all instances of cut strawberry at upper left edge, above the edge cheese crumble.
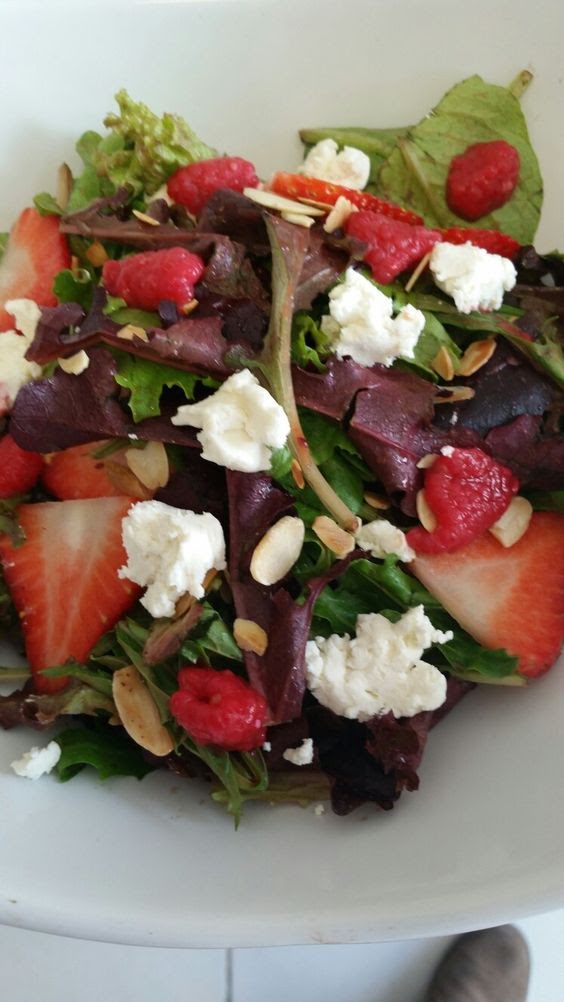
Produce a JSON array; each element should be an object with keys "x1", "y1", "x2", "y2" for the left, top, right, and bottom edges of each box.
[{"x1": 0, "y1": 208, "x2": 70, "y2": 331}]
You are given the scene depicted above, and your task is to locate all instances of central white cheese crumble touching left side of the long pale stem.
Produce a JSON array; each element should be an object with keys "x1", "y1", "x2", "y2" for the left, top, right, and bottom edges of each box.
[{"x1": 172, "y1": 369, "x2": 290, "y2": 473}]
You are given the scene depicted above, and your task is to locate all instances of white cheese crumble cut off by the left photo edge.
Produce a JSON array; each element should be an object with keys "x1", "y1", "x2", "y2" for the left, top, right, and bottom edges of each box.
[{"x1": 0, "y1": 300, "x2": 41, "y2": 416}]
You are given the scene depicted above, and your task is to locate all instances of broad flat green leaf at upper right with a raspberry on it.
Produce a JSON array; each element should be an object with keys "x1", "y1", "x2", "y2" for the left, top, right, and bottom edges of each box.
[{"x1": 380, "y1": 75, "x2": 543, "y2": 243}]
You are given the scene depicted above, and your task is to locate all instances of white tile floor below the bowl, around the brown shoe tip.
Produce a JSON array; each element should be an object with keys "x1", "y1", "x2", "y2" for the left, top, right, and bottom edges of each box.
[{"x1": 0, "y1": 910, "x2": 564, "y2": 1002}]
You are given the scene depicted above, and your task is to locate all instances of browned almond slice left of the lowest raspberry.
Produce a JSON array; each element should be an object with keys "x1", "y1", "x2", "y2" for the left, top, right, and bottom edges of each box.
[{"x1": 111, "y1": 664, "x2": 174, "y2": 757}]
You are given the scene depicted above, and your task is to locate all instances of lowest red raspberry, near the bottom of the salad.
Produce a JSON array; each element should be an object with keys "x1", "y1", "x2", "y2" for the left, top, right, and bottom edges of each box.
[{"x1": 170, "y1": 667, "x2": 267, "y2": 752}]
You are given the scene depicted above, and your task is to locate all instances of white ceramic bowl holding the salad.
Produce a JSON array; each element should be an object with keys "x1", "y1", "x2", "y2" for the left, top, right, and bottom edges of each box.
[{"x1": 0, "y1": 0, "x2": 564, "y2": 947}]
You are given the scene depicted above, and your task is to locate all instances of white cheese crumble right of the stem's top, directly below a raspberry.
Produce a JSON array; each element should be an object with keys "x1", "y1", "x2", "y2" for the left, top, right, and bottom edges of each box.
[{"x1": 322, "y1": 268, "x2": 425, "y2": 367}]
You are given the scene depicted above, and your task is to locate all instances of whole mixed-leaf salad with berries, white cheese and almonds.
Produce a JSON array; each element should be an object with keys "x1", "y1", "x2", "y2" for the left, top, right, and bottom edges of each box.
[{"x1": 0, "y1": 73, "x2": 564, "y2": 823}]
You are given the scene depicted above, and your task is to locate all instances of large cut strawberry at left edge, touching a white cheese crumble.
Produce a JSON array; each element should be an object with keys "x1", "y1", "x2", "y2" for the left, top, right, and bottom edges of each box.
[{"x1": 0, "y1": 497, "x2": 139, "y2": 692}]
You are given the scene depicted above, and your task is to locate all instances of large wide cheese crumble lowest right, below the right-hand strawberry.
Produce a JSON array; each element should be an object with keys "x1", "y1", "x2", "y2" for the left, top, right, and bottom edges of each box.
[{"x1": 306, "y1": 605, "x2": 453, "y2": 720}]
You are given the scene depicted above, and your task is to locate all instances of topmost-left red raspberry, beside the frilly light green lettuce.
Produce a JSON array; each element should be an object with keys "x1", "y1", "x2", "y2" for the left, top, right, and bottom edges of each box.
[{"x1": 166, "y1": 156, "x2": 258, "y2": 215}]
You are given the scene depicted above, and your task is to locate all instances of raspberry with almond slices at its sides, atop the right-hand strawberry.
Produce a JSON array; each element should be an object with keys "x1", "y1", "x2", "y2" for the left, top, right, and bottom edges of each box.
[{"x1": 408, "y1": 449, "x2": 519, "y2": 553}]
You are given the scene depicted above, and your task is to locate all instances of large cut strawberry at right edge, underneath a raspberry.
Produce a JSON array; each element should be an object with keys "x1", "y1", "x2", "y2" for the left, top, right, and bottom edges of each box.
[{"x1": 410, "y1": 511, "x2": 564, "y2": 677}]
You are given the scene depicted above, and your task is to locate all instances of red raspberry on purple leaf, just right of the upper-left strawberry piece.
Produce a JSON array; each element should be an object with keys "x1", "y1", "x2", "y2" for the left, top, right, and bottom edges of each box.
[{"x1": 102, "y1": 247, "x2": 205, "y2": 310}]
